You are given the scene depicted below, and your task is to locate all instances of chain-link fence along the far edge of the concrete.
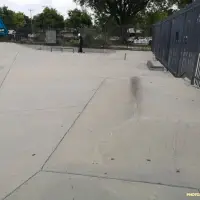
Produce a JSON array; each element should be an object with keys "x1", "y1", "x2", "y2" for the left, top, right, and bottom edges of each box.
[{"x1": 7, "y1": 24, "x2": 151, "y2": 50}]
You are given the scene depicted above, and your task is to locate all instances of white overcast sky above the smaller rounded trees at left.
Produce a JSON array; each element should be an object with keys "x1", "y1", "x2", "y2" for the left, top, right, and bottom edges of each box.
[{"x1": 0, "y1": 0, "x2": 79, "y2": 17}]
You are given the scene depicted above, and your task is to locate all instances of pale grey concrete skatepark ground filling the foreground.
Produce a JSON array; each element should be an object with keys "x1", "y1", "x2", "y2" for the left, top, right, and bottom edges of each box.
[{"x1": 0, "y1": 43, "x2": 200, "y2": 200}]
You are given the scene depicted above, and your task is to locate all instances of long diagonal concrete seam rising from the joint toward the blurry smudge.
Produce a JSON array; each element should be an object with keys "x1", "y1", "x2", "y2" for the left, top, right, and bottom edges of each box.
[{"x1": 41, "y1": 78, "x2": 106, "y2": 170}]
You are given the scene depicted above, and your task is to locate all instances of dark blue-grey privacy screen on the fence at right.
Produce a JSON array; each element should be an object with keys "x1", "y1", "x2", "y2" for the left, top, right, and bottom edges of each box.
[{"x1": 152, "y1": 0, "x2": 200, "y2": 86}]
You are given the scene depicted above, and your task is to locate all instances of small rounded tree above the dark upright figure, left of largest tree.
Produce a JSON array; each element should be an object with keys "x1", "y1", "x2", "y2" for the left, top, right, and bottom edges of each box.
[{"x1": 65, "y1": 9, "x2": 92, "y2": 28}]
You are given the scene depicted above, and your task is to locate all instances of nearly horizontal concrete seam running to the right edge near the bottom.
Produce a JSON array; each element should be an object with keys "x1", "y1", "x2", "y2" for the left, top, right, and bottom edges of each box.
[{"x1": 41, "y1": 170, "x2": 199, "y2": 191}]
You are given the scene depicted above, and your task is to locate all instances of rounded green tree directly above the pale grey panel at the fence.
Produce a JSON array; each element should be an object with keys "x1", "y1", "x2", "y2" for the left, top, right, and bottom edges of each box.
[{"x1": 33, "y1": 7, "x2": 64, "y2": 29}]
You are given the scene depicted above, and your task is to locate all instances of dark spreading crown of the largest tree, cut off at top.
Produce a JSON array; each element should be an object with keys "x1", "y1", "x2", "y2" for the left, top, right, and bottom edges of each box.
[{"x1": 75, "y1": 0, "x2": 150, "y2": 25}]
